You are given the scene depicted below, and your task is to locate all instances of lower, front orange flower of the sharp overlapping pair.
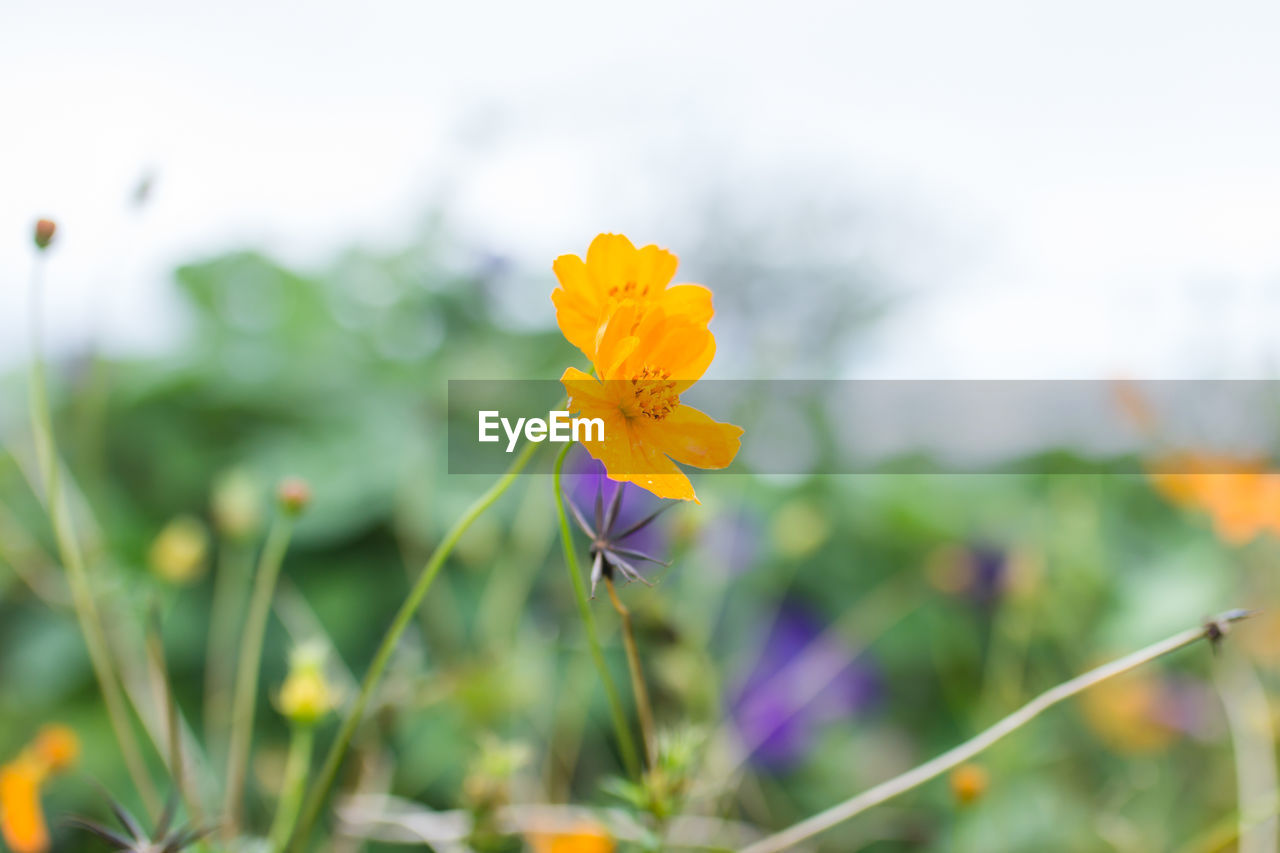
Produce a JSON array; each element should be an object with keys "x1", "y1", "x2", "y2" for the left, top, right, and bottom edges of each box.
[{"x1": 561, "y1": 305, "x2": 742, "y2": 501}]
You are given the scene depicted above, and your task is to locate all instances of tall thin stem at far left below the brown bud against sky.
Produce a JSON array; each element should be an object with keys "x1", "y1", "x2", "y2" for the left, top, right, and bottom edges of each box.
[{"x1": 31, "y1": 251, "x2": 160, "y2": 813}]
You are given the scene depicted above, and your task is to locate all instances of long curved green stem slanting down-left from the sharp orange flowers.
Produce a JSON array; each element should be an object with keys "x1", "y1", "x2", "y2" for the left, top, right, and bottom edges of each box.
[{"x1": 289, "y1": 442, "x2": 538, "y2": 850}]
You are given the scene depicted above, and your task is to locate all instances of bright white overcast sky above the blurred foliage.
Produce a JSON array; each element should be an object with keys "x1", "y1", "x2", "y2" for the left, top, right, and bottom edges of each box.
[{"x1": 0, "y1": 0, "x2": 1280, "y2": 378}]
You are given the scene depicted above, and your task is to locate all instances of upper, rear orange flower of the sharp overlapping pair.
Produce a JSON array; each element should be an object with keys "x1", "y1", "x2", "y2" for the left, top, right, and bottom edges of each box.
[{"x1": 552, "y1": 234, "x2": 713, "y2": 366}]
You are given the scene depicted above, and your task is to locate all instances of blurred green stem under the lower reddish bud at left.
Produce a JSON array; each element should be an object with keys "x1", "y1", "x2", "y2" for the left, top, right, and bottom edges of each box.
[{"x1": 223, "y1": 512, "x2": 293, "y2": 838}]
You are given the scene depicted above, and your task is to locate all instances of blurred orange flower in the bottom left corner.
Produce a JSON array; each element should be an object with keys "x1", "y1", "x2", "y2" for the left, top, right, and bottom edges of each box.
[{"x1": 0, "y1": 725, "x2": 79, "y2": 853}]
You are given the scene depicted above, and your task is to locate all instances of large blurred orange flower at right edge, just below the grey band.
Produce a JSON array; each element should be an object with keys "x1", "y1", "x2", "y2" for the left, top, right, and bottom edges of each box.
[{"x1": 1151, "y1": 453, "x2": 1280, "y2": 544}]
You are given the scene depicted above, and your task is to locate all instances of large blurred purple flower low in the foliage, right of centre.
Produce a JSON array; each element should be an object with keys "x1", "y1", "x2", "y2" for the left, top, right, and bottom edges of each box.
[{"x1": 731, "y1": 602, "x2": 883, "y2": 770}]
